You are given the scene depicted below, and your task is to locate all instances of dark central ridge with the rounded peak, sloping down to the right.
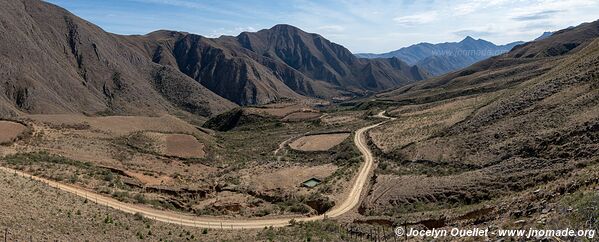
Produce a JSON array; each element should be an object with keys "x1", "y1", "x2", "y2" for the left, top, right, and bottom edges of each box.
[{"x1": 237, "y1": 24, "x2": 426, "y2": 91}]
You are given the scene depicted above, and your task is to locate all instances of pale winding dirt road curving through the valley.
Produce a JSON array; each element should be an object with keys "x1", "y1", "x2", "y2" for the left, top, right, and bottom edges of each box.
[{"x1": 0, "y1": 112, "x2": 393, "y2": 229}]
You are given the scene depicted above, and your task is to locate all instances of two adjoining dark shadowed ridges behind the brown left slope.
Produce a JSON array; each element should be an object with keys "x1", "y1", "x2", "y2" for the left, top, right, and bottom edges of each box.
[{"x1": 124, "y1": 25, "x2": 427, "y2": 105}]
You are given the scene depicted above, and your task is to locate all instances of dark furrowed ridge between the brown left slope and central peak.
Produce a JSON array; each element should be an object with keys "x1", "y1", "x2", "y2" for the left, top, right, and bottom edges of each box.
[{"x1": 124, "y1": 31, "x2": 302, "y2": 105}]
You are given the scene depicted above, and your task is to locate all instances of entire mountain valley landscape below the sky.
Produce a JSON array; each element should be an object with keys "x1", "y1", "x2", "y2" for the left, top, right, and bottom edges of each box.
[{"x1": 0, "y1": 0, "x2": 599, "y2": 241}]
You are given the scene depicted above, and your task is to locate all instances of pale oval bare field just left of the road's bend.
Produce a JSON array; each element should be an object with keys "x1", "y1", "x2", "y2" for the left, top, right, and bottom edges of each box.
[{"x1": 289, "y1": 133, "x2": 350, "y2": 151}]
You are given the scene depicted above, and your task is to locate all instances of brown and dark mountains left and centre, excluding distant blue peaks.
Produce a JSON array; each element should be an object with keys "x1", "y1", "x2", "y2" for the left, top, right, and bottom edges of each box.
[{"x1": 0, "y1": 0, "x2": 427, "y2": 116}]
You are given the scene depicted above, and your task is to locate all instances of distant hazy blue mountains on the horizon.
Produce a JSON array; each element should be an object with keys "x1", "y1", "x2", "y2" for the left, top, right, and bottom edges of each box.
[{"x1": 356, "y1": 36, "x2": 524, "y2": 76}]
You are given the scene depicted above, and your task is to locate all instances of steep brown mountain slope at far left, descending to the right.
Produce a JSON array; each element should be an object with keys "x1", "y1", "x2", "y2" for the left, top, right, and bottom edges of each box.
[{"x1": 0, "y1": 0, "x2": 235, "y2": 116}]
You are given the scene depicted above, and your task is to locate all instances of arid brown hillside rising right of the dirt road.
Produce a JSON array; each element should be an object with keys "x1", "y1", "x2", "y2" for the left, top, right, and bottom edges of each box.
[{"x1": 362, "y1": 19, "x2": 599, "y2": 227}]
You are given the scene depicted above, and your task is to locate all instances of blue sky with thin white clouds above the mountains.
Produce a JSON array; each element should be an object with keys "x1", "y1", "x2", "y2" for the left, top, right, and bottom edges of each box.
[{"x1": 48, "y1": 0, "x2": 599, "y2": 53}]
